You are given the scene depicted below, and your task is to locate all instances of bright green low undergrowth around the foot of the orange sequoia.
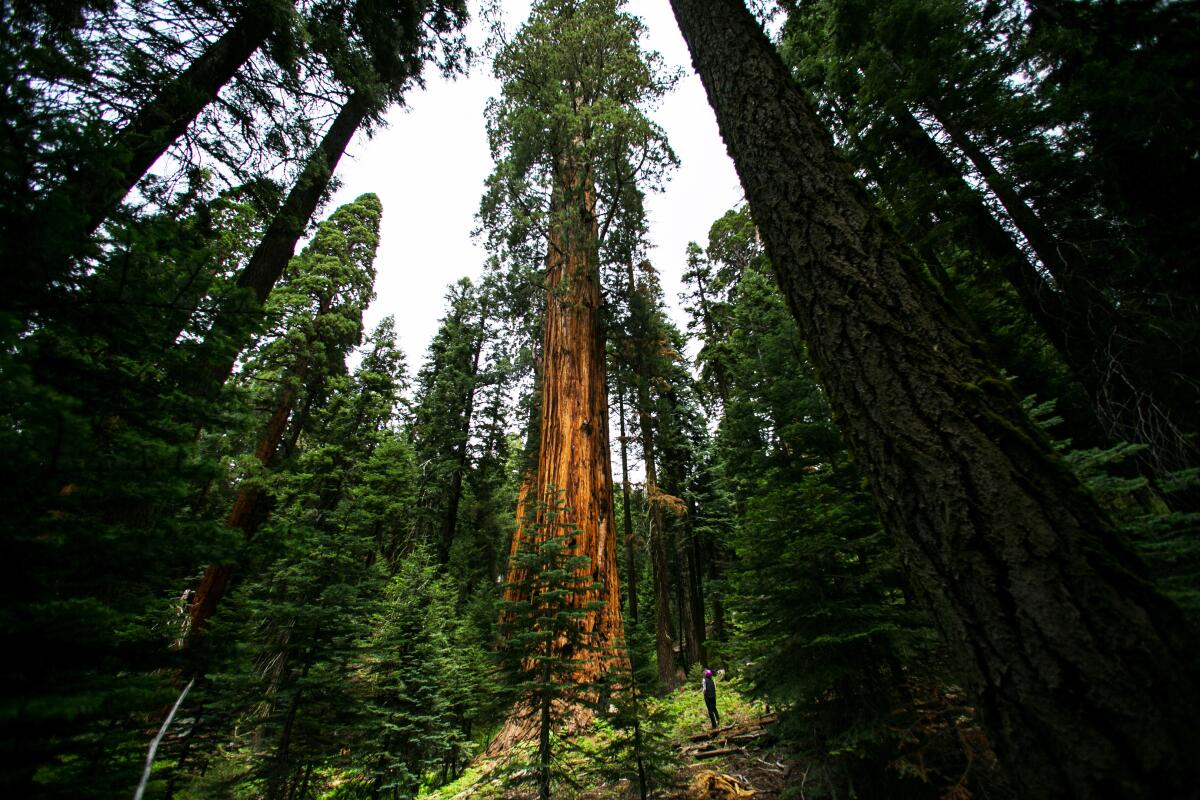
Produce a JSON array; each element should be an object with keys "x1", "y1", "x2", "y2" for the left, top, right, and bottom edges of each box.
[{"x1": 420, "y1": 674, "x2": 766, "y2": 800}]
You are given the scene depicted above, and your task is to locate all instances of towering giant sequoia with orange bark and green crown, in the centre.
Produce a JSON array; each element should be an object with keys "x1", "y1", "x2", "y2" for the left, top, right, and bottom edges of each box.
[{"x1": 481, "y1": 0, "x2": 672, "y2": 738}]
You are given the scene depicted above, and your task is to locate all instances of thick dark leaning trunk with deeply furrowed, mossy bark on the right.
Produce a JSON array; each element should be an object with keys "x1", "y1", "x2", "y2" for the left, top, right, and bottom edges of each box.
[{"x1": 672, "y1": 0, "x2": 1200, "y2": 798}]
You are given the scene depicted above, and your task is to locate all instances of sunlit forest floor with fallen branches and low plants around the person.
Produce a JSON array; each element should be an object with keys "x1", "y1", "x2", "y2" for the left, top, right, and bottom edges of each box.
[{"x1": 421, "y1": 684, "x2": 806, "y2": 800}]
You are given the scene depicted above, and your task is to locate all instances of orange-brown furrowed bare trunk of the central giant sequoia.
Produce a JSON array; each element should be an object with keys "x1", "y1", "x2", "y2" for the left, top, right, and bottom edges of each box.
[{"x1": 490, "y1": 151, "x2": 622, "y2": 752}]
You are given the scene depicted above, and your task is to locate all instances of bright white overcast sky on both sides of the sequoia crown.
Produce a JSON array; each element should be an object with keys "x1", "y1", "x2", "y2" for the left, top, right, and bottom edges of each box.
[{"x1": 326, "y1": 0, "x2": 743, "y2": 374}]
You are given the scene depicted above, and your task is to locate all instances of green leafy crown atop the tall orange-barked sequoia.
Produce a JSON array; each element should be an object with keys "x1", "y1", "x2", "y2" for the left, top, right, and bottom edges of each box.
[{"x1": 480, "y1": 0, "x2": 677, "y2": 264}]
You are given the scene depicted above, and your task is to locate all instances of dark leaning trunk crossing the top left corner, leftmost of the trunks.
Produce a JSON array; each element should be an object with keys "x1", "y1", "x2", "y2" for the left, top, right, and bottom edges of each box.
[{"x1": 7, "y1": 6, "x2": 271, "y2": 308}]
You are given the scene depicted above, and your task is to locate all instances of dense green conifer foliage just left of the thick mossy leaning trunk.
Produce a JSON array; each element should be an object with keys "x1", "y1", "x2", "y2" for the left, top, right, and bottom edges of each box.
[{"x1": 688, "y1": 210, "x2": 984, "y2": 796}]
